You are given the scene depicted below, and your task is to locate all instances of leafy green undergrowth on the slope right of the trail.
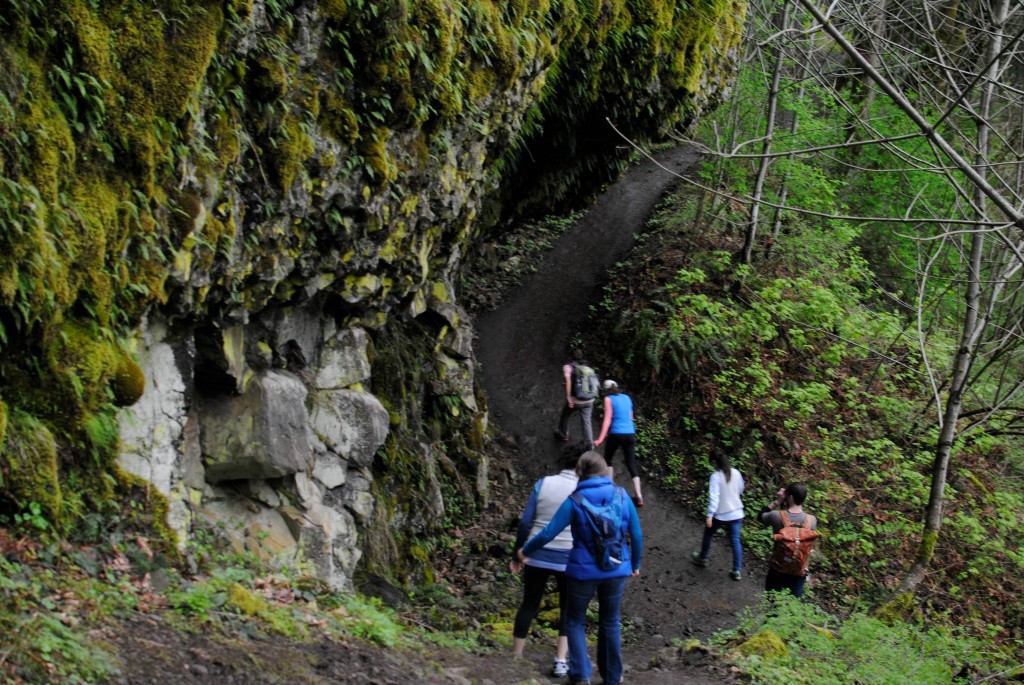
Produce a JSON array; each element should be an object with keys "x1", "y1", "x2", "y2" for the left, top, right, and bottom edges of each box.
[{"x1": 577, "y1": 180, "x2": 1024, "y2": 683}]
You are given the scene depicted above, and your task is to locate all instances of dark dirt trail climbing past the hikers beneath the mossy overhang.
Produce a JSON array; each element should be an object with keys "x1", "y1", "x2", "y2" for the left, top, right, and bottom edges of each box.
[{"x1": 476, "y1": 148, "x2": 764, "y2": 684}]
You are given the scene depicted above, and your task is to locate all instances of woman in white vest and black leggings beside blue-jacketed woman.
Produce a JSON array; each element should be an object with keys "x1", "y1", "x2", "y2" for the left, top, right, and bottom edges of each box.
[{"x1": 509, "y1": 442, "x2": 590, "y2": 678}]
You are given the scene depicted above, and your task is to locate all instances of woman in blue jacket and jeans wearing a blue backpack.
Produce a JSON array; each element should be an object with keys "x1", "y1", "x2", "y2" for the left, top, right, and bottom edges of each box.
[{"x1": 516, "y1": 452, "x2": 643, "y2": 685}]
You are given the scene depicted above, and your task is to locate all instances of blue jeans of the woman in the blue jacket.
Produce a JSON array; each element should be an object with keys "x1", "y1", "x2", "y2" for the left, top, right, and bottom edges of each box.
[{"x1": 565, "y1": 577, "x2": 626, "y2": 685}]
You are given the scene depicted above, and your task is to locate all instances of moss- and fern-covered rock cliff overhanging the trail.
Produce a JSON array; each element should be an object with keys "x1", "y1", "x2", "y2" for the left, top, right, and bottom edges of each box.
[{"x1": 0, "y1": 0, "x2": 744, "y2": 581}]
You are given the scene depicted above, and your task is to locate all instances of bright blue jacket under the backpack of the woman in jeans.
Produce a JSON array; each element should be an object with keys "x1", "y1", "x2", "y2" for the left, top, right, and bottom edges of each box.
[{"x1": 522, "y1": 476, "x2": 643, "y2": 581}]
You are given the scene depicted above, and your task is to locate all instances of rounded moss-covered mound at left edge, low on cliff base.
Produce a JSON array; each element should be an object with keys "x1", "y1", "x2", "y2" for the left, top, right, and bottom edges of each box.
[{"x1": 0, "y1": 412, "x2": 62, "y2": 530}]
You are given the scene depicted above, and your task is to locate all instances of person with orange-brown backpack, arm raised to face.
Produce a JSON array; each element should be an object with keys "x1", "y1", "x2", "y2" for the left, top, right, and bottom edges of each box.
[{"x1": 758, "y1": 483, "x2": 820, "y2": 599}]
